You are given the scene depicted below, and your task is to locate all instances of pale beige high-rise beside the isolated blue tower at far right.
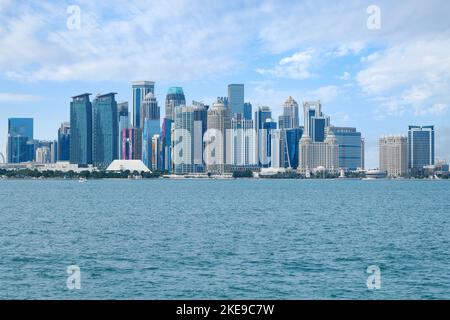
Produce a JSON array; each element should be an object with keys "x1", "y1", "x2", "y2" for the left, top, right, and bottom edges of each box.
[{"x1": 379, "y1": 136, "x2": 408, "y2": 177}]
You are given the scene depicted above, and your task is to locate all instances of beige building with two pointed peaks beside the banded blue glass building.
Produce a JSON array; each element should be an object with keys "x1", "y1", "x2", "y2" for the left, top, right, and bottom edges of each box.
[{"x1": 298, "y1": 128, "x2": 339, "y2": 173}]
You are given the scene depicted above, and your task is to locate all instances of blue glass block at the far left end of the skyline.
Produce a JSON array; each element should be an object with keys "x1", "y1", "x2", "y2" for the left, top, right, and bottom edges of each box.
[{"x1": 7, "y1": 118, "x2": 34, "y2": 163}]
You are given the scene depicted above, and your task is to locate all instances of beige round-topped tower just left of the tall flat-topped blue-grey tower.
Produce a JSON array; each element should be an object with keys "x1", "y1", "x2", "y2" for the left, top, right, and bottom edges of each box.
[{"x1": 205, "y1": 103, "x2": 231, "y2": 174}]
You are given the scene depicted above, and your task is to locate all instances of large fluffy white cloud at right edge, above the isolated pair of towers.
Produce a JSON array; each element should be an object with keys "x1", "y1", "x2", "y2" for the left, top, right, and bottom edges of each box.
[{"x1": 356, "y1": 38, "x2": 450, "y2": 116}]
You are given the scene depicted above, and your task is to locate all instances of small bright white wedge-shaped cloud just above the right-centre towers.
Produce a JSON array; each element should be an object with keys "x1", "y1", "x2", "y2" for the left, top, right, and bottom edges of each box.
[{"x1": 256, "y1": 49, "x2": 315, "y2": 80}]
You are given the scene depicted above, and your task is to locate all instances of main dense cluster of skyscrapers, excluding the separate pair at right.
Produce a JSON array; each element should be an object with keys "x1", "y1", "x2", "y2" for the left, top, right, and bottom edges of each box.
[{"x1": 8, "y1": 81, "x2": 370, "y2": 174}]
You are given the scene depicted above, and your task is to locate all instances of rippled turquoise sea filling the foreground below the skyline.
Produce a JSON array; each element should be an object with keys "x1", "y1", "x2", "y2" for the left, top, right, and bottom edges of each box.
[{"x1": 0, "y1": 179, "x2": 450, "y2": 299}]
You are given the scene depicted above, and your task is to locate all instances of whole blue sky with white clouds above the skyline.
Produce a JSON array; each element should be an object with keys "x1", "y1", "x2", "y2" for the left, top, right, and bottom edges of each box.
[{"x1": 0, "y1": 0, "x2": 450, "y2": 167}]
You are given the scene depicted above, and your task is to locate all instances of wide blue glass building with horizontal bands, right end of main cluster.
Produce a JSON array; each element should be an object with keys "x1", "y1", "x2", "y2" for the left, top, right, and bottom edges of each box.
[{"x1": 330, "y1": 127, "x2": 364, "y2": 170}]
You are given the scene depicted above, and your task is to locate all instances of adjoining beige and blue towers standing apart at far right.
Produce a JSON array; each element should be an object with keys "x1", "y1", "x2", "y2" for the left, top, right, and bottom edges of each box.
[{"x1": 379, "y1": 126, "x2": 435, "y2": 177}]
